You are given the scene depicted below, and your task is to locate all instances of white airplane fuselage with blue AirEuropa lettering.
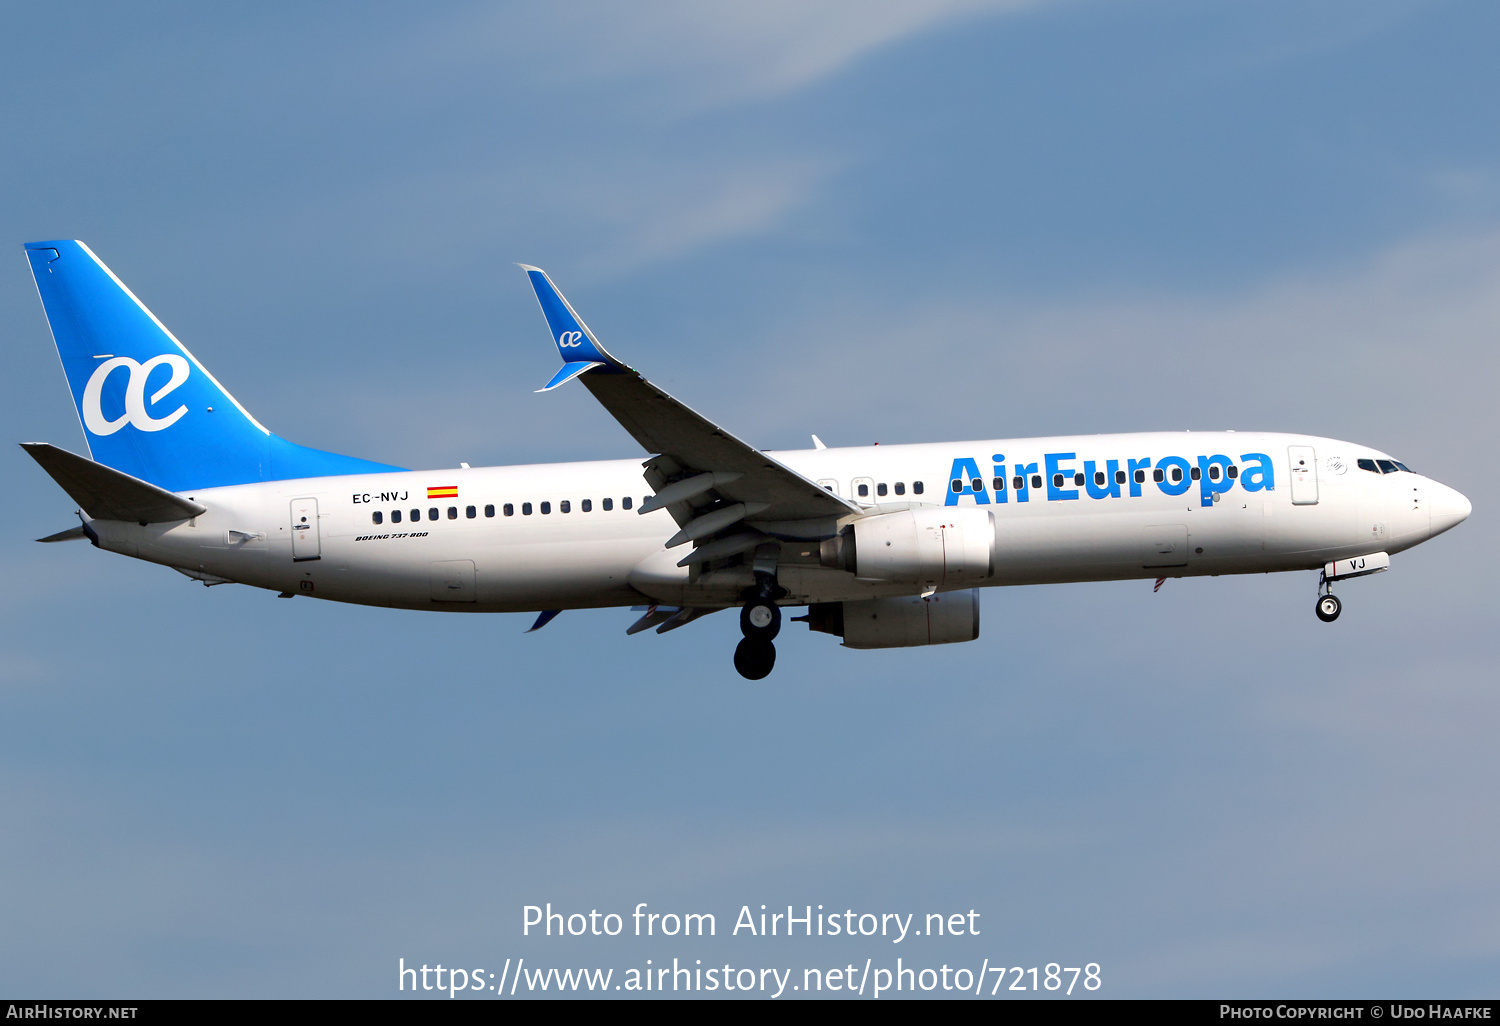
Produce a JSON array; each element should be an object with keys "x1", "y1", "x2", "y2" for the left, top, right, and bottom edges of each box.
[{"x1": 92, "y1": 432, "x2": 1469, "y2": 612}]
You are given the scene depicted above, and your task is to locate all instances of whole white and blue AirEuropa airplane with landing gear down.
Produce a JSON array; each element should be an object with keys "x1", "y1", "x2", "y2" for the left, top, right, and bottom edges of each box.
[{"x1": 23, "y1": 240, "x2": 1472, "y2": 680}]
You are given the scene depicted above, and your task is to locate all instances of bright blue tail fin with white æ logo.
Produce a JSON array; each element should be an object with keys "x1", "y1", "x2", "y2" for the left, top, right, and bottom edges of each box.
[{"x1": 26, "y1": 240, "x2": 401, "y2": 492}]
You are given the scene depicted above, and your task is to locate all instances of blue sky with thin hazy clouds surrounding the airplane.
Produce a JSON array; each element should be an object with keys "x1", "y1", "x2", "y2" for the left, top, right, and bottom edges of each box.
[{"x1": 0, "y1": 0, "x2": 1500, "y2": 998}]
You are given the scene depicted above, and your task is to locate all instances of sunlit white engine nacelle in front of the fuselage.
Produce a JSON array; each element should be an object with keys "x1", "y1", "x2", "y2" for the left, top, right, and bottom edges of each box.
[{"x1": 821, "y1": 506, "x2": 995, "y2": 588}]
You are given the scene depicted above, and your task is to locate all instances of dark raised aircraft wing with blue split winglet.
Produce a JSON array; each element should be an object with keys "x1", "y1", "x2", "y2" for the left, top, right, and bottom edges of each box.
[{"x1": 522, "y1": 264, "x2": 861, "y2": 551}]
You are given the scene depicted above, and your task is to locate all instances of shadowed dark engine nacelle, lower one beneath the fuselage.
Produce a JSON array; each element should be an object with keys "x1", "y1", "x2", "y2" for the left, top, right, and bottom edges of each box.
[{"x1": 807, "y1": 588, "x2": 980, "y2": 648}]
